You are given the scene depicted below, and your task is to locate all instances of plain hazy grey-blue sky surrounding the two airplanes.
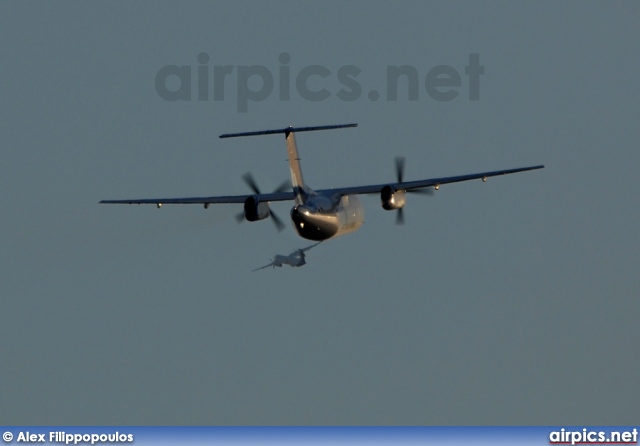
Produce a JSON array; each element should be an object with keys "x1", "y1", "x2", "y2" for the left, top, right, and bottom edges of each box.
[{"x1": 0, "y1": 1, "x2": 640, "y2": 425}]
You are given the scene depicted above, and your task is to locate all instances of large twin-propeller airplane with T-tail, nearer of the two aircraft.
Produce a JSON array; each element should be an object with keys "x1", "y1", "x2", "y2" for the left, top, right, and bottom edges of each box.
[{"x1": 100, "y1": 124, "x2": 544, "y2": 241}]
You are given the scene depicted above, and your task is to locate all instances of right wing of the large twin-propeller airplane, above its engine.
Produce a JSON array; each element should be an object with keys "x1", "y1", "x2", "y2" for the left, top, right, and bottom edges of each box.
[{"x1": 317, "y1": 165, "x2": 544, "y2": 195}]
